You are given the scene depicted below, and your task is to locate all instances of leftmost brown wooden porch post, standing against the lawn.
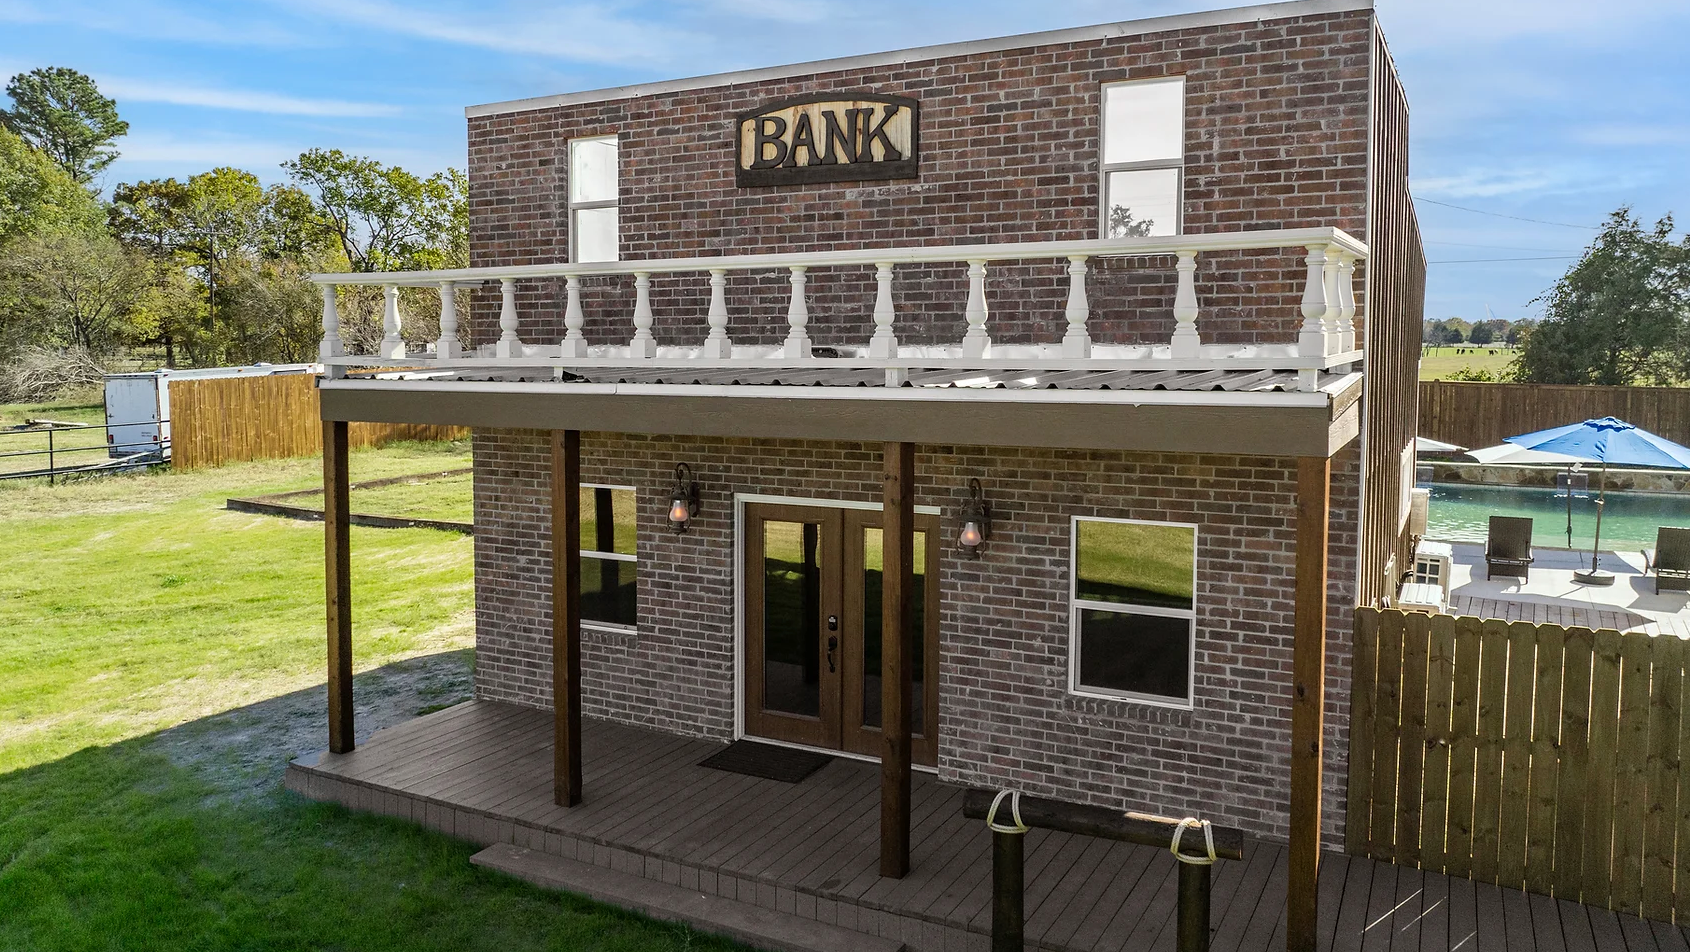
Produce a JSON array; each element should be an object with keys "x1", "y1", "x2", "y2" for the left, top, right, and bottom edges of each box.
[{"x1": 323, "y1": 419, "x2": 353, "y2": 754}]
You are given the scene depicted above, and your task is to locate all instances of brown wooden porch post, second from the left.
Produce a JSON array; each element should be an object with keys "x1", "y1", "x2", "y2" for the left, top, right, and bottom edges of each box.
[{"x1": 551, "y1": 429, "x2": 581, "y2": 807}]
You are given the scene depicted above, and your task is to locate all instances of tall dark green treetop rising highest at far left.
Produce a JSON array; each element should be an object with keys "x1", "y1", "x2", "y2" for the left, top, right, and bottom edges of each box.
[{"x1": 0, "y1": 66, "x2": 128, "y2": 184}]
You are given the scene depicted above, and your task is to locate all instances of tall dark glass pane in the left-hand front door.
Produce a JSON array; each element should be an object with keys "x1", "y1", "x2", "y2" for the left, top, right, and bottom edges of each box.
[{"x1": 762, "y1": 519, "x2": 823, "y2": 717}]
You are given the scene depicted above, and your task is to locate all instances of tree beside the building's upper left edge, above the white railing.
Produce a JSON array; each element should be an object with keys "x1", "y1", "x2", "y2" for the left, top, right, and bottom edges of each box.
[{"x1": 282, "y1": 149, "x2": 470, "y2": 272}]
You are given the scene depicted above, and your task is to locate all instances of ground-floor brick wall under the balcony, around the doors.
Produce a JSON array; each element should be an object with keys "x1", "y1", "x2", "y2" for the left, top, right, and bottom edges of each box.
[{"x1": 475, "y1": 431, "x2": 1357, "y2": 842}]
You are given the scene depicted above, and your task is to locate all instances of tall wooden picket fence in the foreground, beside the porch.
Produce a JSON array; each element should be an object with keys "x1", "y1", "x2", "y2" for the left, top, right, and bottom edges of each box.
[{"x1": 1345, "y1": 609, "x2": 1690, "y2": 923}]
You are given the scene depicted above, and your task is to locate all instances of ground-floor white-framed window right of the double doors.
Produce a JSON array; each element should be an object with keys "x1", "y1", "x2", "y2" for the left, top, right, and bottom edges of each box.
[{"x1": 1068, "y1": 516, "x2": 1197, "y2": 709}]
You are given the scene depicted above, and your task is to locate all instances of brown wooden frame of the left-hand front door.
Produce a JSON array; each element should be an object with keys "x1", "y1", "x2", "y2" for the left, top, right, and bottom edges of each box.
[{"x1": 735, "y1": 502, "x2": 845, "y2": 749}]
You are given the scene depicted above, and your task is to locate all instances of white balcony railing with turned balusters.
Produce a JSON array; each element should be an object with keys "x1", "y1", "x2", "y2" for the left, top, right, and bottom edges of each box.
[{"x1": 313, "y1": 228, "x2": 1367, "y2": 386}]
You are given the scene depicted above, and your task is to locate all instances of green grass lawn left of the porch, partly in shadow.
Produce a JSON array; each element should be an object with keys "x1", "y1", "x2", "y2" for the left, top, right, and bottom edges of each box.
[{"x1": 0, "y1": 439, "x2": 733, "y2": 952}]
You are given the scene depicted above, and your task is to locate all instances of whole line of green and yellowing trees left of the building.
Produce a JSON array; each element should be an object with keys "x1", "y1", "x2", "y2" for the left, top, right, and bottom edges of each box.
[{"x1": 0, "y1": 68, "x2": 468, "y2": 389}]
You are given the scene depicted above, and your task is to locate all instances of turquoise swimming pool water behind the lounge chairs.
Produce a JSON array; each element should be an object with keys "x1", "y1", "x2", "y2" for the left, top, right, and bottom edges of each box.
[{"x1": 1426, "y1": 484, "x2": 1690, "y2": 551}]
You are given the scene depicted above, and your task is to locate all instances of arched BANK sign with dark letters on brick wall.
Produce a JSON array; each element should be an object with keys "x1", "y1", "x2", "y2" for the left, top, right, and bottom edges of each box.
[{"x1": 733, "y1": 93, "x2": 921, "y2": 188}]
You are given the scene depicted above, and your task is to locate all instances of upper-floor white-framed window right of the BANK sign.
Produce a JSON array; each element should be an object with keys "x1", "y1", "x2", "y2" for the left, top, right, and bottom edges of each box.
[{"x1": 1100, "y1": 76, "x2": 1185, "y2": 238}]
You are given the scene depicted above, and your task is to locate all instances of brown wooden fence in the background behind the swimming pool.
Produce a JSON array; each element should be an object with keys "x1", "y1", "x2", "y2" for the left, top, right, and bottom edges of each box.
[{"x1": 1418, "y1": 380, "x2": 1690, "y2": 448}]
